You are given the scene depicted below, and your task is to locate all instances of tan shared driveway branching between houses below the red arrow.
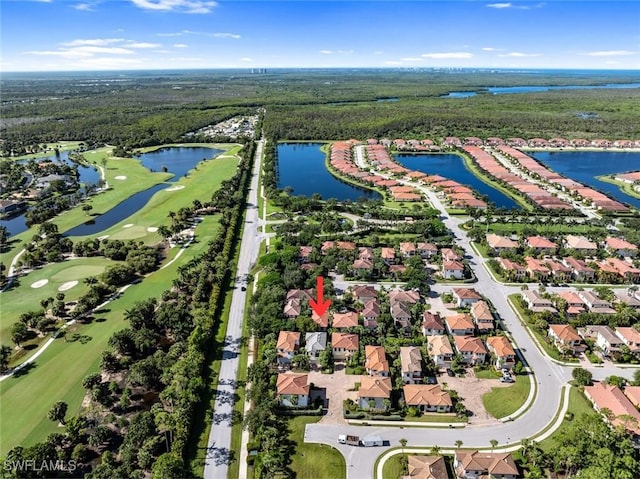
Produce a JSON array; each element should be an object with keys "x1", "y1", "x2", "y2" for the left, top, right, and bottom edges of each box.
[{"x1": 309, "y1": 363, "x2": 362, "y2": 424}]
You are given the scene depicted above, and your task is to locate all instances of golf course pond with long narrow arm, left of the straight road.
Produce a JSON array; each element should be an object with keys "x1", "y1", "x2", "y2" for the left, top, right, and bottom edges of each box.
[{"x1": 64, "y1": 147, "x2": 222, "y2": 236}]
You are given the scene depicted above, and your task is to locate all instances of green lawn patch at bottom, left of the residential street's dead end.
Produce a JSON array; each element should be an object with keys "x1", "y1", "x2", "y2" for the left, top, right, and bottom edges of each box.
[{"x1": 289, "y1": 416, "x2": 346, "y2": 479}]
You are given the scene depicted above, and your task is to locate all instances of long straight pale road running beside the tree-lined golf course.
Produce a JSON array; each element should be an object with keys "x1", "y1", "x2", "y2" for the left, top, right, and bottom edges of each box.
[{"x1": 204, "y1": 140, "x2": 263, "y2": 479}]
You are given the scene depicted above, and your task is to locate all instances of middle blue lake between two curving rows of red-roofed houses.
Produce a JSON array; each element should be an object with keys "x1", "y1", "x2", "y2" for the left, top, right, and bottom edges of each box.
[{"x1": 395, "y1": 154, "x2": 520, "y2": 209}]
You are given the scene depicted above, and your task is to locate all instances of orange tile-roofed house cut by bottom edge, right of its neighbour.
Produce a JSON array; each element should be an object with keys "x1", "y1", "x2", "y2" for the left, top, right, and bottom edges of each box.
[{"x1": 453, "y1": 450, "x2": 519, "y2": 479}]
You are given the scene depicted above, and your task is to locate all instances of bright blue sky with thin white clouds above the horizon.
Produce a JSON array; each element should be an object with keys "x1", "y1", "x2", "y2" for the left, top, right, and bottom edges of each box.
[{"x1": 0, "y1": 0, "x2": 640, "y2": 71}]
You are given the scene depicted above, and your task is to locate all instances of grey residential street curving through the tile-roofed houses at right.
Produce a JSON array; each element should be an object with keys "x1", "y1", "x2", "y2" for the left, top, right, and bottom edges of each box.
[{"x1": 305, "y1": 148, "x2": 633, "y2": 479}]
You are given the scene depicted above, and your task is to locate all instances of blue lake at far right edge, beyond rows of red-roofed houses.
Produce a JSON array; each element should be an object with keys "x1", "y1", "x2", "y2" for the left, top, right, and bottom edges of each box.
[{"x1": 527, "y1": 151, "x2": 640, "y2": 208}]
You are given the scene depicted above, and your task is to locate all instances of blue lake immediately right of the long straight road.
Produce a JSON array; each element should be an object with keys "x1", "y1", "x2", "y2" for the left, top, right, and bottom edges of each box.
[{"x1": 278, "y1": 143, "x2": 381, "y2": 201}]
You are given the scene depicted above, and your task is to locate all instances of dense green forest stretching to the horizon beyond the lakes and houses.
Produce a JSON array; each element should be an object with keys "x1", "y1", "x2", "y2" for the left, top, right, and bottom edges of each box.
[{"x1": 0, "y1": 69, "x2": 640, "y2": 154}]
